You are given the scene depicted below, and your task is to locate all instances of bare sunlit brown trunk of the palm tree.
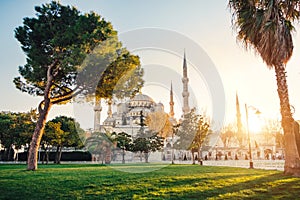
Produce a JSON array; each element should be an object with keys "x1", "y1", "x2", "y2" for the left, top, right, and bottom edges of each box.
[{"x1": 275, "y1": 65, "x2": 300, "y2": 176}]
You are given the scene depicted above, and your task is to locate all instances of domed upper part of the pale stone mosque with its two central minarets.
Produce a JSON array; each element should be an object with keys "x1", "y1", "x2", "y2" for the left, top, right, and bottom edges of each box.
[{"x1": 94, "y1": 53, "x2": 190, "y2": 136}]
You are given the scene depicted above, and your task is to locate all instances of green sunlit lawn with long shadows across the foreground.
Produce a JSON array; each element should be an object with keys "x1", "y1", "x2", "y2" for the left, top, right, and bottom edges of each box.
[{"x1": 0, "y1": 164, "x2": 300, "y2": 199}]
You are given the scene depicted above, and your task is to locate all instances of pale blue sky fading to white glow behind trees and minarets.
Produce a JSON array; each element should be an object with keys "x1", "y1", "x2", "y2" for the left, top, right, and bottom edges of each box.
[{"x1": 0, "y1": 0, "x2": 300, "y2": 128}]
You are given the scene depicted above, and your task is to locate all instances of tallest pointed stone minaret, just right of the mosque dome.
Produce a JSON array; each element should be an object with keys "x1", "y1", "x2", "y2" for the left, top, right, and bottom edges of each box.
[{"x1": 182, "y1": 51, "x2": 190, "y2": 115}]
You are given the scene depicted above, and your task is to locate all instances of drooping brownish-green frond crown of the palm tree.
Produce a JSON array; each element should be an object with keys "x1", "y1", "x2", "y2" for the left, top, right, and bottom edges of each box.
[{"x1": 229, "y1": 0, "x2": 300, "y2": 67}]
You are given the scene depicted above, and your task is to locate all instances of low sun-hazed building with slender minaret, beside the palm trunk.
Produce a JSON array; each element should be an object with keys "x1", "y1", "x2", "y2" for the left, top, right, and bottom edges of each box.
[{"x1": 202, "y1": 94, "x2": 284, "y2": 160}]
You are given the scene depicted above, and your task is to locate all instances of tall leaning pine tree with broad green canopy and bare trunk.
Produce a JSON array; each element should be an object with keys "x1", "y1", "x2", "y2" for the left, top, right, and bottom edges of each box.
[{"x1": 14, "y1": 1, "x2": 143, "y2": 170}]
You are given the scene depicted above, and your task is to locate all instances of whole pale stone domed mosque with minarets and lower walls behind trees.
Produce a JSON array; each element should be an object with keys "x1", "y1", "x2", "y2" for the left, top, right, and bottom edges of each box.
[{"x1": 89, "y1": 53, "x2": 190, "y2": 161}]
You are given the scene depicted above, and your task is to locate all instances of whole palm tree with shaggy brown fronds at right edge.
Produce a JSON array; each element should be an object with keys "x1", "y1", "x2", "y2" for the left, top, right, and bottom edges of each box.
[{"x1": 229, "y1": 0, "x2": 300, "y2": 176}]
